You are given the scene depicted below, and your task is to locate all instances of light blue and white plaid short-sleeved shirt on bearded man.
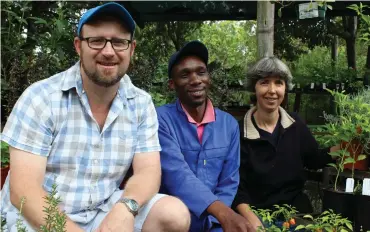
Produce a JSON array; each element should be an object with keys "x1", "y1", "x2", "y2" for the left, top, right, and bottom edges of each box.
[{"x1": 1, "y1": 62, "x2": 160, "y2": 223}]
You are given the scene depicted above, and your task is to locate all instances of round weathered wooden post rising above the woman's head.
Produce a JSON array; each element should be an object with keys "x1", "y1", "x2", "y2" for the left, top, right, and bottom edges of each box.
[{"x1": 257, "y1": 1, "x2": 275, "y2": 58}]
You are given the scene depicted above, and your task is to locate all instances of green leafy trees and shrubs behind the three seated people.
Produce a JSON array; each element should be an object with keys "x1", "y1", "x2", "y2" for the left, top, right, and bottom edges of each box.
[{"x1": 1, "y1": 1, "x2": 370, "y2": 125}]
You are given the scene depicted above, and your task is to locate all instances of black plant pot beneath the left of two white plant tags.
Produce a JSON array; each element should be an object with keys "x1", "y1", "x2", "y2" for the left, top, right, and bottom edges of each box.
[{"x1": 322, "y1": 189, "x2": 356, "y2": 222}]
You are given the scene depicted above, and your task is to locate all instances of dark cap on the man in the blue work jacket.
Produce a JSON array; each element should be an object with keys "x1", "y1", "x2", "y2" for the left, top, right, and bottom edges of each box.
[{"x1": 168, "y1": 40, "x2": 208, "y2": 78}]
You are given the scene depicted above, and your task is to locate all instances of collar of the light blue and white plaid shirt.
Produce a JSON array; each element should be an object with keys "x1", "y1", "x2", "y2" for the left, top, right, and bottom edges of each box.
[{"x1": 61, "y1": 61, "x2": 137, "y2": 98}]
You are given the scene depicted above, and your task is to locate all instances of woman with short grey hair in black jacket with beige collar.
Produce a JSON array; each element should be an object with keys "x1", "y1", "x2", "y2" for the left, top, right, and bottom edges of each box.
[{"x1": 233, "y1": 57, "x2": 337, "y2": 226}]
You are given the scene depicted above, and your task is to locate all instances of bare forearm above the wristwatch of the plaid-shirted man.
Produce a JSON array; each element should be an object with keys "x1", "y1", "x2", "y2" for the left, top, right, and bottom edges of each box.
[{"x1": 123, "y1": 167, "x2": 161, "y2": 207}]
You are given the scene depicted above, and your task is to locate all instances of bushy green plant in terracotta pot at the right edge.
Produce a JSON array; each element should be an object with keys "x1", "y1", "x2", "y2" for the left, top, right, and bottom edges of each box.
[{"x1": 317, "y1": 89, "x2": 370, "y2": 176}]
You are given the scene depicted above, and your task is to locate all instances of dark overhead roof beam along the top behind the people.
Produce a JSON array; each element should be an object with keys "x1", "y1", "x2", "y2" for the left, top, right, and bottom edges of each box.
[{"x1": 119, "y1": 1, "x2": 370, "y2": 27}]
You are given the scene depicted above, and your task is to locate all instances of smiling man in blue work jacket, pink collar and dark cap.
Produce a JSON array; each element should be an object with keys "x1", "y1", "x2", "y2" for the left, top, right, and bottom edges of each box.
[{"x1": 157, "y1": 41, "x2": 254, "y2": 232}]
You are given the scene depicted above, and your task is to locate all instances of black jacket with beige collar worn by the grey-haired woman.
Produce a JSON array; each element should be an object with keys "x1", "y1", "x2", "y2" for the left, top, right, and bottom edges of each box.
[{"x1": 233, "y1": 108, "x2": 332, "y2": 211}]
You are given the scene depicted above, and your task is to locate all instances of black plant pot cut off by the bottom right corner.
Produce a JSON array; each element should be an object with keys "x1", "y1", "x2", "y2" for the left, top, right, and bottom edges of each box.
[{"x1": 354, "y1": 195, "x2": 370, "y2": 231}]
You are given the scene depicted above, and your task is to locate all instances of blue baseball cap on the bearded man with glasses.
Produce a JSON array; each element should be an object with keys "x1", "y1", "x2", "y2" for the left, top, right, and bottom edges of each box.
[{"x1": 77, "y1": 2, "x2": 135, "y2": 36}]
